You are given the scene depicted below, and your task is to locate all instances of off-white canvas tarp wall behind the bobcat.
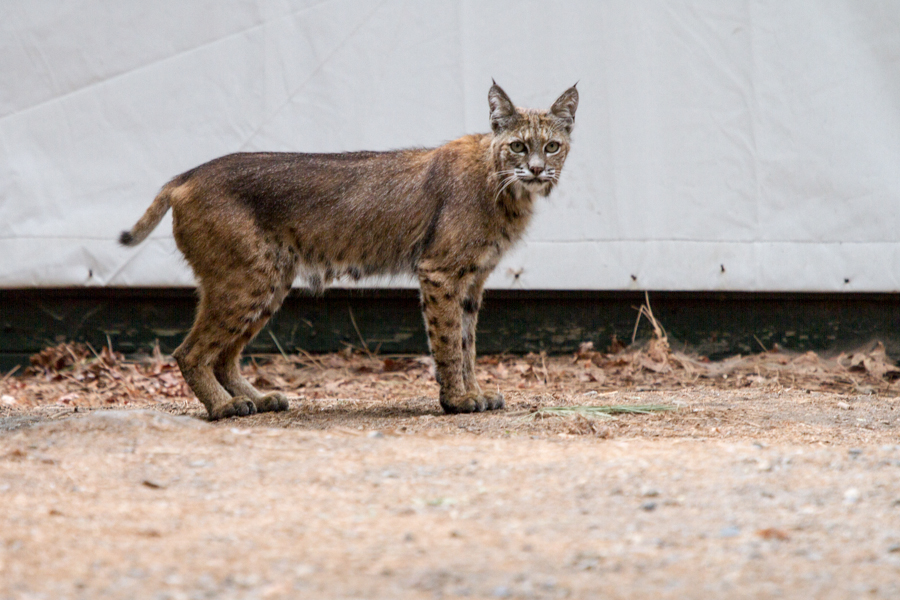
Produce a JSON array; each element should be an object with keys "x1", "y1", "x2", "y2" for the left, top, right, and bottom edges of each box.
[{"x1": 0, "y1": 0, "x2": 900, "y2": 291}]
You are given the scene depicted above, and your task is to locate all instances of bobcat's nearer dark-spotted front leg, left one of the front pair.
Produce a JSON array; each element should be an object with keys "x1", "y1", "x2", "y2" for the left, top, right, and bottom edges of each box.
[{"x1": 419, "y1": 269, "x2": 493, "y2": 413}]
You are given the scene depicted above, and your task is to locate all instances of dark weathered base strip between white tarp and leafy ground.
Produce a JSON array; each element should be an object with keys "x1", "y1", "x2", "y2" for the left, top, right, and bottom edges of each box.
[{"x1": 0, "y1": 288, "x2": 900, "y2": 372}]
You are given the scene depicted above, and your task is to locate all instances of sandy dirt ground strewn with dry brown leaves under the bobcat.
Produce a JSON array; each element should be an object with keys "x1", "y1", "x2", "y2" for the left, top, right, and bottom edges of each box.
[{"x1": 0, "y1": 338, "x2": 900, "y2": 600}]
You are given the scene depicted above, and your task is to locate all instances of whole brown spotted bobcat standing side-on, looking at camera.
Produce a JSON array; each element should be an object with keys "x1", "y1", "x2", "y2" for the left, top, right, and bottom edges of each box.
[{"x1": 119, "y1": 83, "x2": 578, "y2": 420}]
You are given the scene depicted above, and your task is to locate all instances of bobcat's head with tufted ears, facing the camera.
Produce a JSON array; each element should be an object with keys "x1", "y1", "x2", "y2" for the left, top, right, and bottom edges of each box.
[{"x1": 488, "y1": 83, "x2": 578, "y2": 196}]
